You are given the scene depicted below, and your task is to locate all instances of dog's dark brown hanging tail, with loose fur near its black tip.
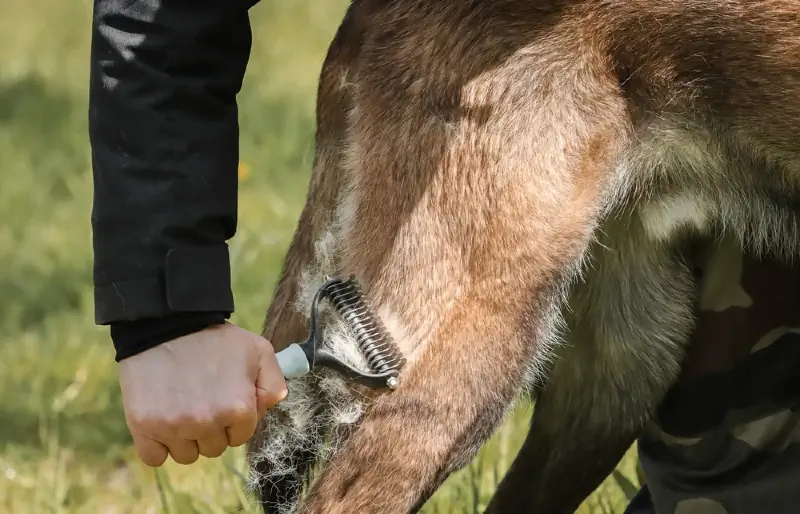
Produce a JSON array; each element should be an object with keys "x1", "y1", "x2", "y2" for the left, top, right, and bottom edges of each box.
[{"x1": 248, "y1": 6, "x2": 363, "y2": 508}]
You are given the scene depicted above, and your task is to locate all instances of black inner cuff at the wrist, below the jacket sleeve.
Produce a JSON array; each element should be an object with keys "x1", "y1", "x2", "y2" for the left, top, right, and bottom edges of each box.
[{"x1": 111, "y1": 312, "x2": 229, "y2": 362}]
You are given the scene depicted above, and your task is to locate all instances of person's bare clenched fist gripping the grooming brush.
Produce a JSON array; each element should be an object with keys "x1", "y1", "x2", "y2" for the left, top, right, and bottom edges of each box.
[{"x1": 115, "y1": 323, "x2": 287, "y2": 466}]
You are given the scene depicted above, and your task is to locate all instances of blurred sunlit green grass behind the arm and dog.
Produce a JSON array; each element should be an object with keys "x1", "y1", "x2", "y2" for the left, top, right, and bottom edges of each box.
[{"x1": 0, "y1": 0, "x2": 636, "y2": 508}]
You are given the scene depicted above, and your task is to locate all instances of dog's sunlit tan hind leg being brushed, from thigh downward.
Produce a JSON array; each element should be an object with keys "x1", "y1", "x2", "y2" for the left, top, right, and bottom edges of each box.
[{"x1": 290, "y1": 22, "x2": 627, "y2": 508}]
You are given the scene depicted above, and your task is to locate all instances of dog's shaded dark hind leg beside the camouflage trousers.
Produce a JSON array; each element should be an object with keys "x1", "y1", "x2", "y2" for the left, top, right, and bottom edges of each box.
[{"x1": 486, "y1": 219, "x2": 696, "y2": 514}]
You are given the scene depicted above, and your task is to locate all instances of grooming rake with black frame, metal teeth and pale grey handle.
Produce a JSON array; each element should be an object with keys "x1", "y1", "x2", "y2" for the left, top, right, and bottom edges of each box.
[{"x1": 276, "y1": 275, "x2": 406, "y2": 389}]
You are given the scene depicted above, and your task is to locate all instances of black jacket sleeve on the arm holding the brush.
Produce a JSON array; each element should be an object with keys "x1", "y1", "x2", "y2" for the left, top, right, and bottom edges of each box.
[{"x1": 89, "y1": 0, "x2": 256, "y2": 360}]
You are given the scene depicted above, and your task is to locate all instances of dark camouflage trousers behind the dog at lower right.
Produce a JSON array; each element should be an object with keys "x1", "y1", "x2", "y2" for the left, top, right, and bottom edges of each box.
[{"x1": 625, "y1": 235, "x2": 800, "y2": 514}]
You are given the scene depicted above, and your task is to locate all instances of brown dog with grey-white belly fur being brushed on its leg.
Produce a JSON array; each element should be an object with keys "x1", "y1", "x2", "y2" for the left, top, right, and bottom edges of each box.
[{"x1": 244, "y1": 0, "x2": 800, "y2": 514}]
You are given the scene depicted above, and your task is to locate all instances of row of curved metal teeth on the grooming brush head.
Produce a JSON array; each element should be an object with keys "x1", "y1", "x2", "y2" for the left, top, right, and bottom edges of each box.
[{"x1": 325, "y1": 275, "x2": 406, "y2": 374}]
